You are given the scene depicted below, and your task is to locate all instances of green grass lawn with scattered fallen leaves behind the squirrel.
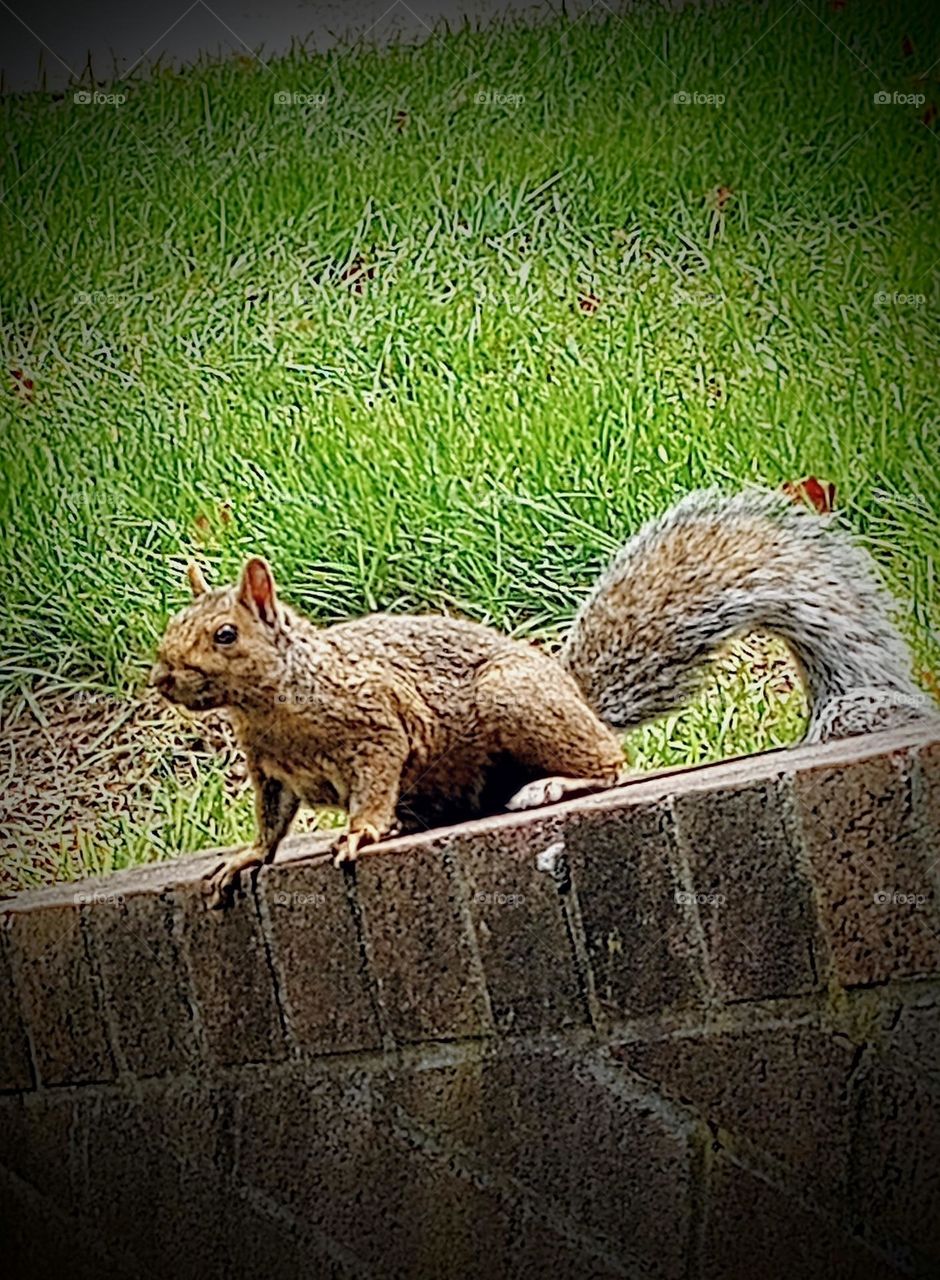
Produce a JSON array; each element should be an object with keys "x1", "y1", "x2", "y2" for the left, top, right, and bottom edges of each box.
[{"x1": 0, "y1": 0, "x2": 940, "y2": 883}]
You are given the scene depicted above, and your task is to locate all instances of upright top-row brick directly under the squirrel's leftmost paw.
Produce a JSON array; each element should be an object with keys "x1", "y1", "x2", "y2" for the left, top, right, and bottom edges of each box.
[{"x1": 177, "y1": 882, "x2": 287, "y2": 1066}]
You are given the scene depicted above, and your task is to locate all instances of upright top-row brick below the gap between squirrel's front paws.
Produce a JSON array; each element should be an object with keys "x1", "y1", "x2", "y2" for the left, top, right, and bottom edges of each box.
[{"x1": 259, "y1": 863, "x2": 382, "y2": 1053}]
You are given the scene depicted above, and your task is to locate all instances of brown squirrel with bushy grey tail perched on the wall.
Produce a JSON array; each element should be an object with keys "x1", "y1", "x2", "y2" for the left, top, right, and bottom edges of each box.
[{"x1": 151, "y1": 490, "x2": 936, "y2": 906}]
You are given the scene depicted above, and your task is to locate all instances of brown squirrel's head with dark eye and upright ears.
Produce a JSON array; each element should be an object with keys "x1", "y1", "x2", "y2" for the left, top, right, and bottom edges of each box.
[{"x1": 150, "y1": 559, "x2": 283, "y2": 712}]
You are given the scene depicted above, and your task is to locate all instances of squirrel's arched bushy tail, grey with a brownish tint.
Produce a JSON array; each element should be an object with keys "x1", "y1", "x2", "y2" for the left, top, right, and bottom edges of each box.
[{"x1": 560, "y1": 489, "x2": 930, "y2": 739}]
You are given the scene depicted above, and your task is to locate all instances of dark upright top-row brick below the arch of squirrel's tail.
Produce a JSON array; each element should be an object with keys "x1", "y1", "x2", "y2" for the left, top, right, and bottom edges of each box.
[{"x1": 674, "y1": 778, "x2": 817, "y2": 1000}]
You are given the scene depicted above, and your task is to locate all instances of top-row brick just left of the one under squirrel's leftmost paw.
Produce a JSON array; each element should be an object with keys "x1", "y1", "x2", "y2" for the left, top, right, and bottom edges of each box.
[{"x1": 82, "y1": 892, "x2": 196, "y2": 1076}]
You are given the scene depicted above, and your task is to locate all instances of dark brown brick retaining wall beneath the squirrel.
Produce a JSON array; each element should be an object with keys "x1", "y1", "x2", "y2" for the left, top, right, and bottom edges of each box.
[{"x1": 0, "y1": 733, "x2": 940, "y2": 1280}]
